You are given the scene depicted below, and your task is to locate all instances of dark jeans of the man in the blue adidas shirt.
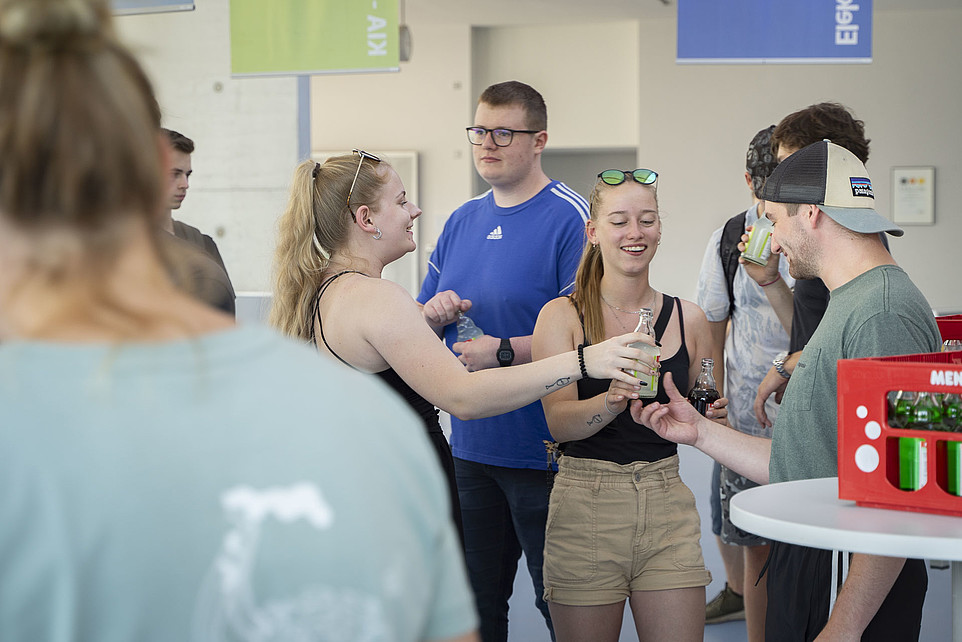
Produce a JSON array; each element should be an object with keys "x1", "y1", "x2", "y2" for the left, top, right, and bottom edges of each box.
[{"x1": 454, "y1": 458, "x2": 554, "y2": 642}]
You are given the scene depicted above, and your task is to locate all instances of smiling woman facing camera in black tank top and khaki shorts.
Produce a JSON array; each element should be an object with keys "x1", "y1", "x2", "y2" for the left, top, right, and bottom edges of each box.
[{"x1": 532, "y1": 169, "x2": 727, "y2": 641}]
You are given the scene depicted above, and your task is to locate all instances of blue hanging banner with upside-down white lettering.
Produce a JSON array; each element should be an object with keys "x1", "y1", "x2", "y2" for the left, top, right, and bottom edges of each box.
[{"x1": 677, "y1": 0, "x2": 872, "y2": 64}]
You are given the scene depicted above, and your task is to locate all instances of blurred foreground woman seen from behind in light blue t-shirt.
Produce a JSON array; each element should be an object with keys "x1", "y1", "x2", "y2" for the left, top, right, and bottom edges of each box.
[{"x1": 0, "y1": 0, "x2": 480, "y2": 642}]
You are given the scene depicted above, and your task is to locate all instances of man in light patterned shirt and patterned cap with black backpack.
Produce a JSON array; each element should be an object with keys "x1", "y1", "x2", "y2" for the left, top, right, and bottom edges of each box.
[{"x1": 697, "y1": 125, "x2": 795, "y2": 642}]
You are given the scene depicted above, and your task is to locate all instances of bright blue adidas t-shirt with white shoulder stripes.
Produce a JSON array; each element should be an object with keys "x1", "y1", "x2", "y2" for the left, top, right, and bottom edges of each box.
[{"x1": 418, "y1": 181, "x2": 588, "y2": 469}]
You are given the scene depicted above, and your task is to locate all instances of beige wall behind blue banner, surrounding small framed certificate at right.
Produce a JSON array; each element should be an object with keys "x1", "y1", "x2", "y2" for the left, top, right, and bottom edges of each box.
[{"x1": 639, "y1": 8, "x2": 962, "y2": 309}]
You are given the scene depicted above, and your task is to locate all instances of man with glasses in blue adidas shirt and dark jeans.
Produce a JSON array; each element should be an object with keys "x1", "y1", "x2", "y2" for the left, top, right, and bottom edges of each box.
[{"x1": 418, "y1": 81, "x2": 588, "y2": 642}]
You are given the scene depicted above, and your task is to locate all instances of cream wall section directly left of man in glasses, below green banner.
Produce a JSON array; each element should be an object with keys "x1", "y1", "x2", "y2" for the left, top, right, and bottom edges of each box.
[{"x1": 311, "y1": 25, "x2": 477, "y2": 268}]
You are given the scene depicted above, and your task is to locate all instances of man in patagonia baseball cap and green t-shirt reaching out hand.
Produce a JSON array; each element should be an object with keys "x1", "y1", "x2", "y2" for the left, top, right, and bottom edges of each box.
[{"x1": 631, "y1": 141, "x2": 941, "y2": 641}]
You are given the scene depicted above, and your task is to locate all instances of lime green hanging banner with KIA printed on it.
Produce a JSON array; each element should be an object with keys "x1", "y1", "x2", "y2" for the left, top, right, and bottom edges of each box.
[{"x1": 230, "y1": 0, "x2": 399, "y2": 76}]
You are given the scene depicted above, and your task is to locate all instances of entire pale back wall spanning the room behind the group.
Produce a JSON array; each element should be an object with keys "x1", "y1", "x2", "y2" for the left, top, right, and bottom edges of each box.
[{"x1": 110, "y1": 0, "x2": 962, "y2": 309}]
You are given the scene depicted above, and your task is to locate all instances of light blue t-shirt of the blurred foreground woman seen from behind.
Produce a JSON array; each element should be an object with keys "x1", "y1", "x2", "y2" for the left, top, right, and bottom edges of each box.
[{"x1": 0, "y1": 327, "x2": 477, "y2": 642}]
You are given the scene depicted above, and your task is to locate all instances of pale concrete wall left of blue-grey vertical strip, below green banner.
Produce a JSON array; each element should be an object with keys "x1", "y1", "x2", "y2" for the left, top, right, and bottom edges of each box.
[{"x1": 117, "y1": 0, "x2": 298, "y2": 291}]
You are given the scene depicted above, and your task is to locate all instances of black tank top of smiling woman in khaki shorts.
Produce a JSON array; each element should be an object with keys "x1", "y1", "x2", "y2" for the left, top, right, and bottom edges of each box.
[{"x1": 563, "y1": 294, "x2": 690, "y2": 464}]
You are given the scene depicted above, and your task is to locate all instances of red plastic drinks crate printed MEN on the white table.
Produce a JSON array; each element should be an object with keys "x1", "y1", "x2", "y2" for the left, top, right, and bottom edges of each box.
[{"x1": 838, "y1": 315, "x2": 962, "y2": 517}]
